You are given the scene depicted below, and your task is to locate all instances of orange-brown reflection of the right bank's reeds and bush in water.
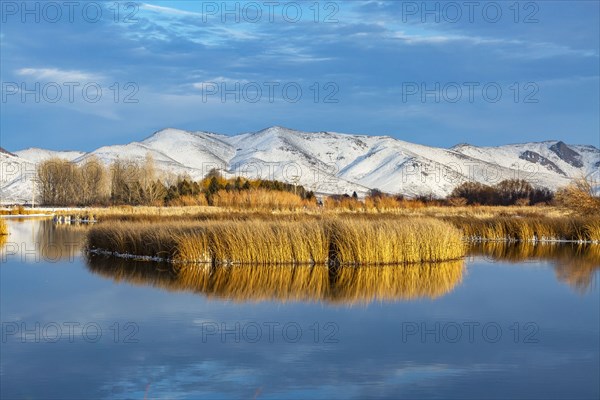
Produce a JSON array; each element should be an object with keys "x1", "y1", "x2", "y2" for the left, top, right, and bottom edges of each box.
[{"x1": 470, "y1": 242, "x2": 600, "y2": 293}]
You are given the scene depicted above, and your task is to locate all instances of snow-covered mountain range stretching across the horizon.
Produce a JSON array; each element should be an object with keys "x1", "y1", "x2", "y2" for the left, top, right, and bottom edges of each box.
[{"x1": 0, "y1": 126, "x2": 600, "y2": 203}]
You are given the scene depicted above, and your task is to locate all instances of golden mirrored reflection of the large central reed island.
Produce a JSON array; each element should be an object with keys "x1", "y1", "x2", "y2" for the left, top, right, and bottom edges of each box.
[{"x1": 87, "y1": 255, "x2": 464, "y2": 304}]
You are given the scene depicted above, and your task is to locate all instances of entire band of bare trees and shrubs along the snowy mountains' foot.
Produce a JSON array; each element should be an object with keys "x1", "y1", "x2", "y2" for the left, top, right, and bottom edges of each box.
[{"x1": 36, "y1": 156, "x2": 584, "y2": 209}]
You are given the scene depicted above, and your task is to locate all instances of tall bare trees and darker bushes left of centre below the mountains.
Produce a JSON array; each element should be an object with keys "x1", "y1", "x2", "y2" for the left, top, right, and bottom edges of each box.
[{"x1": 36, "y1": 156, "x2": 315, "y2": 207}]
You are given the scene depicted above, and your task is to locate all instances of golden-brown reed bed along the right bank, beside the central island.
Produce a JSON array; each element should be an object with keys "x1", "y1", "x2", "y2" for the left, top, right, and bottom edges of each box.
[{"x1": 445, "y1": 216, "x2": 600, "y2": 241}]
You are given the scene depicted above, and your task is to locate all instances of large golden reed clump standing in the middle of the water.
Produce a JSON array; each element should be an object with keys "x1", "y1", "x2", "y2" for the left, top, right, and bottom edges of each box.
[{"x1": 88, "y1": 218, "x2": 465, "y2": 265}]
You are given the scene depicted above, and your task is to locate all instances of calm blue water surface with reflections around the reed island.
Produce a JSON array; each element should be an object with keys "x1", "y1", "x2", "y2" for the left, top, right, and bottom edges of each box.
[{"x1": 0, "y1": 220, "x2": 600, "y2": 399}]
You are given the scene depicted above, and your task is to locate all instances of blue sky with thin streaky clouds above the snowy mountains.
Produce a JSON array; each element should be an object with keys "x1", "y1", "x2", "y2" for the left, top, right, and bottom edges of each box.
[{"x1": 0, "y1": 1, "x2": 600, "y2": 151}]
